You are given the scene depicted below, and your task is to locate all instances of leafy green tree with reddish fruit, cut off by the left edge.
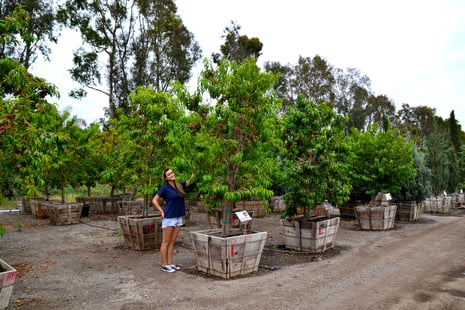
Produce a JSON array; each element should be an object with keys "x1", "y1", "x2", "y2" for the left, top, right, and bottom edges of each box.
[{"x1": 0, "y1": 5, "x2": 58, "y2": 214}]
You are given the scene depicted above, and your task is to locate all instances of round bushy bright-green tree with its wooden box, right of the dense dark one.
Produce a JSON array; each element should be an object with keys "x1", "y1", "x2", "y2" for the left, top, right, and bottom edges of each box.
[{"x1": 350, "y1": 123, "x2": 416, "y2": 230}]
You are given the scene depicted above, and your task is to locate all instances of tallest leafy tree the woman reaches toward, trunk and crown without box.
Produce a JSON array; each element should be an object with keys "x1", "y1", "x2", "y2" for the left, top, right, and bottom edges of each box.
[{"x1": 186, "y1": 58, "x2": 281, "y2": 233}]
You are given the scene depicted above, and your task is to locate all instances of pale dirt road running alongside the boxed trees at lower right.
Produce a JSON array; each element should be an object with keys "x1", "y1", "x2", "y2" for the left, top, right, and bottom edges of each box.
[{"x1": 167, "y1": 217, "x2": 465, "y2": 310}]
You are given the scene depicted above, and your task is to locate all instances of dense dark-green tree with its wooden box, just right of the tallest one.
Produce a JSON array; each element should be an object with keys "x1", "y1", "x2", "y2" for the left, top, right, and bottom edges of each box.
[{"x1": 282, "y1": 96, "x2": 351, "y2": 253}]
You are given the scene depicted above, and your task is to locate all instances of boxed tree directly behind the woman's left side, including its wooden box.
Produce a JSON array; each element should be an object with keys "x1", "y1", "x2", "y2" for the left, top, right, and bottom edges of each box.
[{"x1": 113, "y1": 87, "x2": 184, "y2": 250}]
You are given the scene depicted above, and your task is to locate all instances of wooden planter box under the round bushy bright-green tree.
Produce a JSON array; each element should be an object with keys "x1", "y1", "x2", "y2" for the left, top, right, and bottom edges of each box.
[{"x1": 355, "y1": 205, "x2": 397, "y2": 230}]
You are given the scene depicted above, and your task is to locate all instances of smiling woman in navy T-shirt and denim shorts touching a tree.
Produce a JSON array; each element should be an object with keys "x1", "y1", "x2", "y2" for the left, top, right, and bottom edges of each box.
[{"x1": 152, "y1": 169, "x2": 195, "y2": 272}]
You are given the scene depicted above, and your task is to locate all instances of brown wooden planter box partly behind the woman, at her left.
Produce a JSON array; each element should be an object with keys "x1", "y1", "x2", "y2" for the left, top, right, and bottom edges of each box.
[{"x1": 118, "y1": 215, "x2": 163, "y2": 251}]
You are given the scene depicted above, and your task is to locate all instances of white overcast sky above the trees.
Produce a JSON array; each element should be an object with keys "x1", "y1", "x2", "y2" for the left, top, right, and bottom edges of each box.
[{"x1": 29, "y1": 0, "x2": 465, "y2": 129}]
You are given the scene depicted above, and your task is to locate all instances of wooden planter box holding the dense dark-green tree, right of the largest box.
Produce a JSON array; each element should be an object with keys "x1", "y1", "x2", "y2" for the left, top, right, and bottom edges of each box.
[{"x1": 283, "y1": 216, "x2": 340, "y2": 253}]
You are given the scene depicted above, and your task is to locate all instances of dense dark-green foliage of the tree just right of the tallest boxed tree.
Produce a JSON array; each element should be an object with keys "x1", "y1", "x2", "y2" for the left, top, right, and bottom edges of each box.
[{"x1": 282, "y1": 96, "x2": 351, "y2": 217}]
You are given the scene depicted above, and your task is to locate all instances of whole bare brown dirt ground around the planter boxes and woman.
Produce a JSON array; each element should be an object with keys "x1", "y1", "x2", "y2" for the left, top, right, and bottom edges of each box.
[{"x1": 0, "y1": 203, "x2": 465, "y2": 310}]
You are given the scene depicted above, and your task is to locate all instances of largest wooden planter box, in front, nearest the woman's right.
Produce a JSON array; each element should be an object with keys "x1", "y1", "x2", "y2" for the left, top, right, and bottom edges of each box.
[{"x1": 191, "y1": 229, "x2": 267, "y2": 279}]
